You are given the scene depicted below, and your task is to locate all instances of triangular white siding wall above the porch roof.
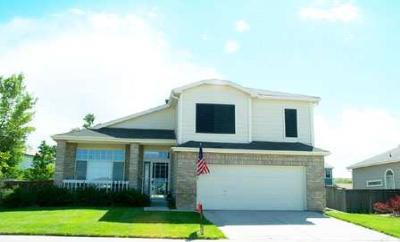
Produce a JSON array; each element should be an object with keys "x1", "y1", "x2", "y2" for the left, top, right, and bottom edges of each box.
[{"x1": 109, "y1": 108, "x2": 176, "y2": 129}]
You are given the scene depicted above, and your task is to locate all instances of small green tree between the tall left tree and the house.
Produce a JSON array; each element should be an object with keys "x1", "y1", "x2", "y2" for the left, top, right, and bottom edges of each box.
[{"x1": 25, "y1": 141, "x2": 56, "y2": 180}]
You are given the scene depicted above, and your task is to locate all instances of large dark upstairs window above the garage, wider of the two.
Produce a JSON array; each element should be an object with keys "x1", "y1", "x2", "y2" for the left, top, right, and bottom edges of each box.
[{"x1": 196, "y1": 103, "x2": 235, "y2": 134}]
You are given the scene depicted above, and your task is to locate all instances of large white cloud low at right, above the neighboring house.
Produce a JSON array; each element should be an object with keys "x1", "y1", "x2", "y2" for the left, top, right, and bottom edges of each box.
[{"x1": 315, "y1": 108, "x2": 400, "y2": 177}]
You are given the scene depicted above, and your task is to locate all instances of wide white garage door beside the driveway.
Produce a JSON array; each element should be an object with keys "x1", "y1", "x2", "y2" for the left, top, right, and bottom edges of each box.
[{"x1": 197, "y1": 165, "x2": 306, "y2": 210}]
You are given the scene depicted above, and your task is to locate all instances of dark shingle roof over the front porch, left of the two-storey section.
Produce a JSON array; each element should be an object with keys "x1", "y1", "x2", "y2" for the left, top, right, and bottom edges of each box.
[{"x1": 54, "y1": 128, "x2": 175, "y2": 139}]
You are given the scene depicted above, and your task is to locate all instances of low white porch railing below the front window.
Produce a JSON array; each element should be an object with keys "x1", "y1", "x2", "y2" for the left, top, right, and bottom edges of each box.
[{"x1": 62, "y1": 180, "x2": 129, "y2": 191}]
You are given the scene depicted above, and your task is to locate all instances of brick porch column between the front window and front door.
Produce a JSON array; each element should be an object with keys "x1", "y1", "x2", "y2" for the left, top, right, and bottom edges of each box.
[{"x1": 127, "y1": 144, "x2": 140, "y2": 190}]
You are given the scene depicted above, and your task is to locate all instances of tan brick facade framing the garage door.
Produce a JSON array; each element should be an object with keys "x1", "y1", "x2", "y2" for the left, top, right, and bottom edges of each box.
[{"x1": 171, "y1": 152, "x2": 325, "y2": 211}]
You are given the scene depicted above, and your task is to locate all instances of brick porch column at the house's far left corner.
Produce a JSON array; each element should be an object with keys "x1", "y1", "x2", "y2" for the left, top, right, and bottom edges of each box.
[{"x1": 54, "y1": 140, "x2": 77, "y2": 185}]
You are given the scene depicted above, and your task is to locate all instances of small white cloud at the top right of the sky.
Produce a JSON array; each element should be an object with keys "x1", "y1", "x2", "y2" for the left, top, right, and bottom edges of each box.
[{"x1": 299, "y1": 3, "x2": 360, "y2": 22}]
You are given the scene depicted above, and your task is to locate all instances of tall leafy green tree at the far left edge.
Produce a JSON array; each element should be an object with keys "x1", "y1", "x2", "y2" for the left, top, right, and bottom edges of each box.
[{"x1": 0, "y1": 74, "x2": 36, "y2": 177}]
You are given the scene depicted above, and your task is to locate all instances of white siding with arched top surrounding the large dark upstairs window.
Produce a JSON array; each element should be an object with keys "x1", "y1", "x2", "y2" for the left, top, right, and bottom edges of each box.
[{"x1": 178, "y1": 85, "x2": 249, "y2": 143}]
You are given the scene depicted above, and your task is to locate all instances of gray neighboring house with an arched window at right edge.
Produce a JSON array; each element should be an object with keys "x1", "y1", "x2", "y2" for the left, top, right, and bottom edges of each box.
[{"x1": 348, "y1": 146, "x2": 400, "y2": 189}]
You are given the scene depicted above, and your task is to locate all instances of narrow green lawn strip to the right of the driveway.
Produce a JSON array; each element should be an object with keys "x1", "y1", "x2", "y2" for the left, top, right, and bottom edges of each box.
[{"x1": 326, "y1": 210, "x2": 400, "y2": 238}]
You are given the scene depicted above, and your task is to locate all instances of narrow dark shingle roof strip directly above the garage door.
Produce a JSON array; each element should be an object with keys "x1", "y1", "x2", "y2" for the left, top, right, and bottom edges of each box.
[{"x1": 178, "y1": 141, "x2": 327, "y2": 152}]
